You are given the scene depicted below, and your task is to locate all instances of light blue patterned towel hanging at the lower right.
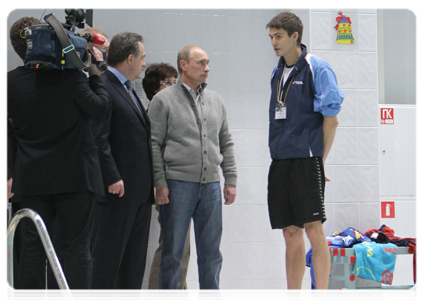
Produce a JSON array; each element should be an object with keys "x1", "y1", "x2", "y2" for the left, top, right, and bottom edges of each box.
[{"x1": 353, "y1": 242, "x2": 398, "y2": 285}]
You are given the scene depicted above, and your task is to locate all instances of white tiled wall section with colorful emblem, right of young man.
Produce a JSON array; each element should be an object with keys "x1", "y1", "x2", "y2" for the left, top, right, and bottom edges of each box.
[{"x1": 309, "y1": 8, "x2": 382, "y2": 299}]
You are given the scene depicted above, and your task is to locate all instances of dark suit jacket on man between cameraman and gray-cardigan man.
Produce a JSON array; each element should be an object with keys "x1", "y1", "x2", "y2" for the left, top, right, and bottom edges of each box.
[{"x1": 93, "y1": 70, "x2": 154, "y2": 203}]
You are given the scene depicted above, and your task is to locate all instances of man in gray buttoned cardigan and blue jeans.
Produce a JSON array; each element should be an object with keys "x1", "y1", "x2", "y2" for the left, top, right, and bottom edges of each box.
[{"x1": 149, "y1": 45, "x2": 237, "y2": 300}]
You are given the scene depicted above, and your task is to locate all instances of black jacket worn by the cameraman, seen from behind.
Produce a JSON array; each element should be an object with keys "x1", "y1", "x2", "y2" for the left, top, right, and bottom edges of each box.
[{"x1": 6, "y1": 67, "x2": 111, "y2": 195}]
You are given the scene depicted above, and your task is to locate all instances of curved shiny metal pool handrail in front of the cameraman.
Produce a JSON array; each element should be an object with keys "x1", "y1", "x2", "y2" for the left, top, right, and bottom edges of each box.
[{"x1": 6, "y1": 208, "x2": 73, "y2": 300}]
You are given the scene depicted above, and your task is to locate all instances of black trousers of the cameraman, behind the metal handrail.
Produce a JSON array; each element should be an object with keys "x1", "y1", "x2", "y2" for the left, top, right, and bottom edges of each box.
[{"x1": 19, "y1": 190, "x2": 94, "y2": 300}]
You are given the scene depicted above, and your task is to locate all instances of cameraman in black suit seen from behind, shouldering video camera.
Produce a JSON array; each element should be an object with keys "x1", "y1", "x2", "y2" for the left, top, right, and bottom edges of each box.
[{"x1": 5, "y1": 18, "x2": 111, "y2": 300}]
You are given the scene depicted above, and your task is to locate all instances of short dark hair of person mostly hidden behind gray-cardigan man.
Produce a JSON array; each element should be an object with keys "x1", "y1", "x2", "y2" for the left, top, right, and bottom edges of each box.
[{"x1": 142, "y1": 63, "x2": 178, "y2": 100}]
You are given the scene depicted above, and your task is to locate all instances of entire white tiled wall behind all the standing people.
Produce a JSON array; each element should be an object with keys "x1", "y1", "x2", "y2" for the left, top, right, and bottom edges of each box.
[{"x1": 6, "y1": 8, "x2": 386, "y2": 300}]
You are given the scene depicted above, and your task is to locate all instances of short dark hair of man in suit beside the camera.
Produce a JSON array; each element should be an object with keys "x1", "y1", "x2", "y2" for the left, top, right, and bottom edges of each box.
[{"x1": 107, "y1": 32, "x2": 142, "y2": 67}]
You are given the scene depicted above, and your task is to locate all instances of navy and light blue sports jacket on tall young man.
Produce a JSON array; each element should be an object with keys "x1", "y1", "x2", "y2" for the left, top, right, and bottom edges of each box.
[{"x1": 269, "y1": 45, "x2": 344, "y2": 160}]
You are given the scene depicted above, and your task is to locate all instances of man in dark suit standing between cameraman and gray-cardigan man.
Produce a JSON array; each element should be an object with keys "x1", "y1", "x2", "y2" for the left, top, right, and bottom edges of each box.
[{"x1": 92, "y1": 32, "x2": 154, "y2": 300}]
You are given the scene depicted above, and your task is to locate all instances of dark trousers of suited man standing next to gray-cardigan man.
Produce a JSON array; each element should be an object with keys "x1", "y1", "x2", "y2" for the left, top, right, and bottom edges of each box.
[{"x1": 92, "y1": 202, "x2": 151, "y2": 300}]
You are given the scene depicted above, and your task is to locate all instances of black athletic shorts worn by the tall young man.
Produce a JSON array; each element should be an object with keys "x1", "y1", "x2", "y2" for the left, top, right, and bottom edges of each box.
[{"x1": 267, "y1": 157, "x2": 326, "y2": 229}]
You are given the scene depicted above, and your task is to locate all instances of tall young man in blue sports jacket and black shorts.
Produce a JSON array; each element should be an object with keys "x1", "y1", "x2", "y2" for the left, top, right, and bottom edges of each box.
[{"x1": 266, "y1": 12, "x2": 344, "y2": 300}]
